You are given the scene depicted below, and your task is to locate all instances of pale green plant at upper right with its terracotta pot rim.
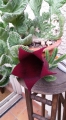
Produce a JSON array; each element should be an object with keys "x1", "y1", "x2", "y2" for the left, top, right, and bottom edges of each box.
[{"x1": 25, "y1": 0, "x2": 65, "y2": 50}]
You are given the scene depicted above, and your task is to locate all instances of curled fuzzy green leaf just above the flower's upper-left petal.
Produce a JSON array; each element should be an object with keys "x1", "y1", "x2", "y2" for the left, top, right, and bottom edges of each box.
[{"x1": 7, "y1": 31, "x2": 32, "y2": 48}]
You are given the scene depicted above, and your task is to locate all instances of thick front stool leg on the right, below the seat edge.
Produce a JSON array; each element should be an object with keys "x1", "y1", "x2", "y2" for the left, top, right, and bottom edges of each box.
[{"x1": 51, "y1": 94, "x2": 58, "y2": 120}]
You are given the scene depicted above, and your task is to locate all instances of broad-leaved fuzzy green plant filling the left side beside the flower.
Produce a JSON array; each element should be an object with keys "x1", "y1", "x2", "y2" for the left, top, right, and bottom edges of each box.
[{"x1": 0, "y1": 0, "x2": 32, "y2": 87}]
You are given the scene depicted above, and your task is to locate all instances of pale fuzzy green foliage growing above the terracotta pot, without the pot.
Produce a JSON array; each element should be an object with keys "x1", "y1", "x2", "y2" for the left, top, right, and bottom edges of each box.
[{"x1": 29, "y1": 0, "x2": 66, "y2": 40}]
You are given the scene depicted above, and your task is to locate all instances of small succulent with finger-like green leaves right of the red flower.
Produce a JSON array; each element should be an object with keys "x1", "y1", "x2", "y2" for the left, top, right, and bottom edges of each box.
[{"x1": 44, "y1": 48, "x2": 66, "y2": 82}]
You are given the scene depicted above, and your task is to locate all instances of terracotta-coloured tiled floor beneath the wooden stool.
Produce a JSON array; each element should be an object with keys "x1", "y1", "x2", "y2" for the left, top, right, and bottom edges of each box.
[{"x1": 0, "y1": 95, "x2": 48, "y2": 120}]
